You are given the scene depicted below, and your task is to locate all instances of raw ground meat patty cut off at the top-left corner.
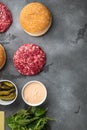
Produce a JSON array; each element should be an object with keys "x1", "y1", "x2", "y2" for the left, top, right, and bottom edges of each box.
[{"x1": 0, "y1": 2, "x2": 12, "y2": 33}]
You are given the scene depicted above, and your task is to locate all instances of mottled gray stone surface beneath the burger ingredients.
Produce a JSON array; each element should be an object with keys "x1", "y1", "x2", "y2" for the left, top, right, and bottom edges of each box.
[{"x1": 0, "y1": 0, "x2": 87, "y2": 130}]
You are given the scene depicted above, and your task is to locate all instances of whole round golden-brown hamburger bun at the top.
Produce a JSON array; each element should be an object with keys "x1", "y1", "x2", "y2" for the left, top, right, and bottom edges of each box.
[{"x1": 20, "y1": 2, "x2": 52, "y2": 36}]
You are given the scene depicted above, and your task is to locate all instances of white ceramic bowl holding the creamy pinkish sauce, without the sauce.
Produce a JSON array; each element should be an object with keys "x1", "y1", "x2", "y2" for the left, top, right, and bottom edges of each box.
[{"x1": 21, "y1": 80, "x2": 47, "y2": 106}]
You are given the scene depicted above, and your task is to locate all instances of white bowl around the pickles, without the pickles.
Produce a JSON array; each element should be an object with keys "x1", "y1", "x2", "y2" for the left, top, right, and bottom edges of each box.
[{"x1": 0, "y1": 80, "x2": 18, "y2": 105}]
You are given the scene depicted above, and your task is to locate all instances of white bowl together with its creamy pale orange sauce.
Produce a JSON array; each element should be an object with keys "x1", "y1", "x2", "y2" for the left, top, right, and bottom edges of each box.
[{"x1": 22, "y1": 81, "x2": 47, "y2": 106}]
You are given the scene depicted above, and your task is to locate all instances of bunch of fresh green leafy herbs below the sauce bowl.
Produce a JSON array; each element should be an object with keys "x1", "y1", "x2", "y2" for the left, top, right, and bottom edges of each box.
[{"x1": 6, "y1": 107, "x2": 53, "y2": 130}]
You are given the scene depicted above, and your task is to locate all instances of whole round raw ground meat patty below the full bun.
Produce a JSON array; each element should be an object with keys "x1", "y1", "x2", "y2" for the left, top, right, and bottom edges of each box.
[{"x1": 13, "y1": 43, "x2": 46, "y2": 75}]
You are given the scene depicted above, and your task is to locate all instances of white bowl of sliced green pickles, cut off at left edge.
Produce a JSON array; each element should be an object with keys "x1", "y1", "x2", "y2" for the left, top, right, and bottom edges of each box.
[{"x1": 0, "y1": 80, "x2": 18, "y2": 105}]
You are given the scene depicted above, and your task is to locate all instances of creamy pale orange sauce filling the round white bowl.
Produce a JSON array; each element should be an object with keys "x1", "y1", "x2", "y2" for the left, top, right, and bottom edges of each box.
[{"x1": 23, "y1": 82, "x2": 46, "y2": 104}]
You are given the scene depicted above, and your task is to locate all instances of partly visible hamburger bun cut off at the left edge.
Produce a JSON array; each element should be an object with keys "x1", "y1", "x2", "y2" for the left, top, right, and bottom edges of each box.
[{"x1": 0, "y1": 44, "x2": 6, "y2": 69}]
